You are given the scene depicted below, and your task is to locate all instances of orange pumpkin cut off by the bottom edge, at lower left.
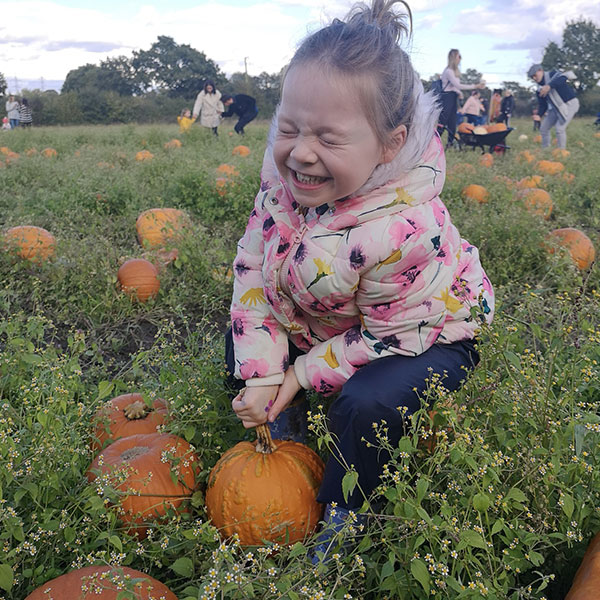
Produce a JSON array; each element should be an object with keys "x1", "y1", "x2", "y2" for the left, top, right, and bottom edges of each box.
[{"x1": 25, "y1": 565, "x2": 177, "y2": 600}]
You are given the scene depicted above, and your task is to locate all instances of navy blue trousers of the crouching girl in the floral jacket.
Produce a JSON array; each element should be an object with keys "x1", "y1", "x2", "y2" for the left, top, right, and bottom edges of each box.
[{"x1": 225, "y1": 331, "x2": 479, "y2": 509}]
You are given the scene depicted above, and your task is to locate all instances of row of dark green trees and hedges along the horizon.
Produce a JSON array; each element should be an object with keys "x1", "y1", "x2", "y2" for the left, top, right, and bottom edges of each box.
[{"x1": 0, "y1": 19, "x2": 600, "y2": 125}]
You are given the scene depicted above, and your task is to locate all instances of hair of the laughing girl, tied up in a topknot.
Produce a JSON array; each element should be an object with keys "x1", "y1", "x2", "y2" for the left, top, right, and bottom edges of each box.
[{"x1": 284, "y1": 0, "x2": 419, "y2": 145}]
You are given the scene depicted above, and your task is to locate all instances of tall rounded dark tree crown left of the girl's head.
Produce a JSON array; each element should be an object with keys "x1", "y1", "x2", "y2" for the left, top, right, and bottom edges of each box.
[{"x1": 131, "y1": 35, "x2": 225, "y2": 98}]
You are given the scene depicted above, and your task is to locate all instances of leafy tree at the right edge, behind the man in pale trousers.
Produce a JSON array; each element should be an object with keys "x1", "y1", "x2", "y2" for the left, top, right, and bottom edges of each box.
[{"x1": 542, "y1": 19, "x2": 600, "y2": 92}]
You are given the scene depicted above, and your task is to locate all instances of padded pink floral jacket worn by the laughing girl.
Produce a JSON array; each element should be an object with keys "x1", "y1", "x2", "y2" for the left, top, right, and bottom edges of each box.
[{"x1": 231, "y1": 135, "x2": 494, "y2": 394}]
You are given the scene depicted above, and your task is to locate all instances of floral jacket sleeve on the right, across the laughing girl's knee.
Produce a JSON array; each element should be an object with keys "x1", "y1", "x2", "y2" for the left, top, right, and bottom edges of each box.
[{"x1": 295, "y1": 214, "x2": 466, "y2": 394}]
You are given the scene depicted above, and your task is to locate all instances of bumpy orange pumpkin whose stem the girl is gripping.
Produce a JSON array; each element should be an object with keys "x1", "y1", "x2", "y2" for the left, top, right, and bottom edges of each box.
[{"x1": 206, "y1": 425, "x2": 324, "y2": 546}]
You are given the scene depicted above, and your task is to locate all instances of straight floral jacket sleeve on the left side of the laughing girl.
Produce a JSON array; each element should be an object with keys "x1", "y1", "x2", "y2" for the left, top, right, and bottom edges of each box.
[{"x1": 231, "y1": 192, "x2": 289, "y2": 385}]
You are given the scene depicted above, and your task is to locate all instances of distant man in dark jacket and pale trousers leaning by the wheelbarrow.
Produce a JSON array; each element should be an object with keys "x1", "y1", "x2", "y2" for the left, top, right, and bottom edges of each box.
[{"x1": 527, "y1": 64, "x2": 579, "y2": 148}]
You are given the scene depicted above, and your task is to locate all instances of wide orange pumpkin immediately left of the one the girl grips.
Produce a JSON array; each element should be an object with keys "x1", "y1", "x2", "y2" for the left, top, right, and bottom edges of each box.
[{"x1": 86, "y1": 433, "x2": 200, "y2": 539}]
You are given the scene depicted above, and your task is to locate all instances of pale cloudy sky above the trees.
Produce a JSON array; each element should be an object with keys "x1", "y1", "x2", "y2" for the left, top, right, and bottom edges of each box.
[{"x1": 0, "y1": 0, "x2": 600, "y2": 94}]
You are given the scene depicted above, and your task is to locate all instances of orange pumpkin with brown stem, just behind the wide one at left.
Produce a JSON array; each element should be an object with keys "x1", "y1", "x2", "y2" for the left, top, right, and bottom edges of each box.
[{"x1": 92, "y1": 393, "x2": 168, "y2": 450}]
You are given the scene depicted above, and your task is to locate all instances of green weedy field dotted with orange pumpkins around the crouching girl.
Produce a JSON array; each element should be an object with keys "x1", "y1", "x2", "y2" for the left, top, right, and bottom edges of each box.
[{"x1": 0, "y1": 118, "x2": 600, "y2": 600}]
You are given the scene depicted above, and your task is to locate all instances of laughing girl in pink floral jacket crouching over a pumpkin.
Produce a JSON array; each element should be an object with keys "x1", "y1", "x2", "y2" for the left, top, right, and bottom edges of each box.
[{"x1": 227, "y1": 0, "x2": 494, "y2": 552}]
